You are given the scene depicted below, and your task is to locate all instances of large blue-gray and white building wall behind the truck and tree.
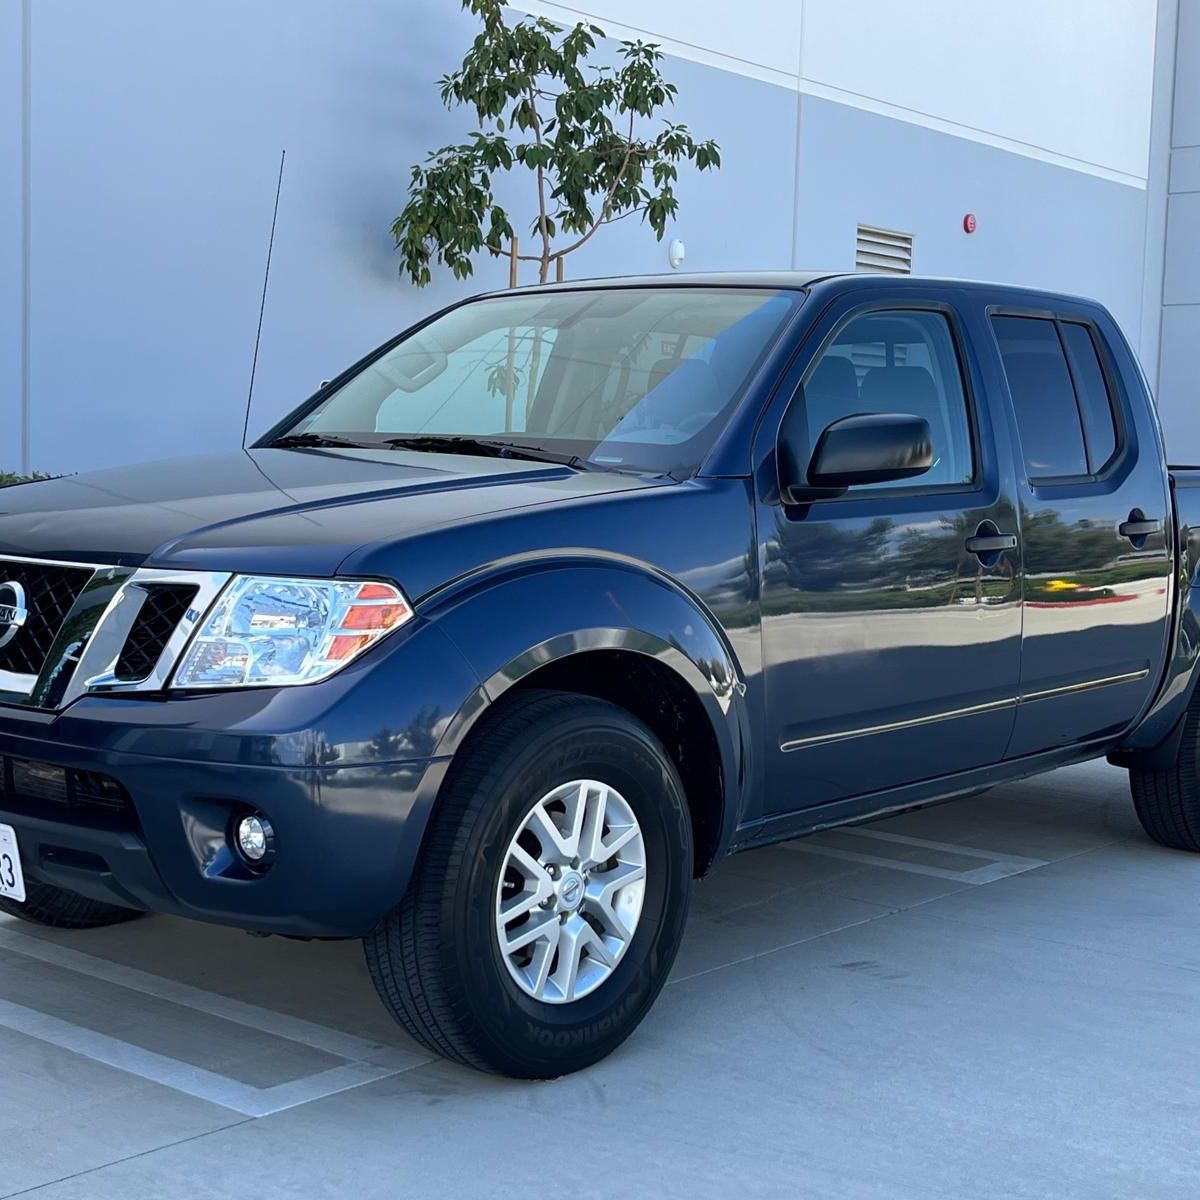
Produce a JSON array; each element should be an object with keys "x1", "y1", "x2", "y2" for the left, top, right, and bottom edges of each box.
[{"x1": 0, "y1": 0, "x2": 1180, "y2": 470}]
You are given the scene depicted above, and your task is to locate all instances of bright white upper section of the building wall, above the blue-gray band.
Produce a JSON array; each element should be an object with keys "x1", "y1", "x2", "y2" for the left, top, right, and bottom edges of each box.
[{"x1": 522, "y1": 0, "x2": 1157, "y2": 182}]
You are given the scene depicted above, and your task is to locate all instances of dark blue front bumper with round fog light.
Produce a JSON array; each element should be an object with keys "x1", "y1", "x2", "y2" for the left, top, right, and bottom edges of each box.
[{"x1": 0, "y1": 696, "x2": 446, "y2": 937}]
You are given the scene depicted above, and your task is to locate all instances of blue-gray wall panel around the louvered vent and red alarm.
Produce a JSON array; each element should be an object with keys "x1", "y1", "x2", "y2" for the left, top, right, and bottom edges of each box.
[{"x1": 796, "y1": 96, "x2": 1146, "y2": 337}]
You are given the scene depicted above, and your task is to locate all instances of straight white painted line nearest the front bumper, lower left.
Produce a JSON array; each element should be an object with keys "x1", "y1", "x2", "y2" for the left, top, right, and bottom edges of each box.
[{"x1": 0, "y1": 926, "x2": 431, "y2": 1070}]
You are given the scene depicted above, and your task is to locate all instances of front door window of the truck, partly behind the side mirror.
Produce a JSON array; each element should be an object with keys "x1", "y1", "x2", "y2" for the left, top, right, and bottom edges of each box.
[{"x1": 803, "y1": 310, "x2": 974, "y2": 491}]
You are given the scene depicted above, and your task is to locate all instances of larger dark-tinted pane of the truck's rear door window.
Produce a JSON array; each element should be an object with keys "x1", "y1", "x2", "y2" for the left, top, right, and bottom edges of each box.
[{"x1": 992, "y1": 317, "x2": 1088, "y2": 479}]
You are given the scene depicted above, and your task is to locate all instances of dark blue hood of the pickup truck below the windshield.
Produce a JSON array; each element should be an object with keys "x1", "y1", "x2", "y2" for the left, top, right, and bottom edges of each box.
[{"x1": 0, "y1": 450, "x2": 649, "y2": 576}]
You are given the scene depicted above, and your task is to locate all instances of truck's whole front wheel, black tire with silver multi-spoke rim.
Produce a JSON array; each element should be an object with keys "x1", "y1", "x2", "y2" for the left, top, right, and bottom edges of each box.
[{"x1": 365, "y1": 692, "x2": 692, "y2": 1079}]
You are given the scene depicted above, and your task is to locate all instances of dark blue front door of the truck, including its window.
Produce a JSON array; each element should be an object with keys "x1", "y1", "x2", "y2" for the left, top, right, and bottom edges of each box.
[{"x1": 757, "y1": 288, "x2": 1021, "y2": 814}]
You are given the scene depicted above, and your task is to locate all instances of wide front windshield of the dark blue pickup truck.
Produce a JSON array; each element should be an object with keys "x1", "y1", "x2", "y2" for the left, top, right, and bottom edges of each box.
[{"x1": 275, "y1": 287, "x2": 803, "y2": 475}]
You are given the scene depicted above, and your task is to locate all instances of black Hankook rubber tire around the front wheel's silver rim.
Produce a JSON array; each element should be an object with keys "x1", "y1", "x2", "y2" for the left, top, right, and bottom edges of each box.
[{"x1": 364, "y1": 691, "x2": 692, "y2": 1079}]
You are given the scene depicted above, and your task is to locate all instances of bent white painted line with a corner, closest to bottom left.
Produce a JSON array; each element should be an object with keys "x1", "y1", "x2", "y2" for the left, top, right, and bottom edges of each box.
[{"x1": 0, "y1": 1000, "x2": 400, "y2": 1117}]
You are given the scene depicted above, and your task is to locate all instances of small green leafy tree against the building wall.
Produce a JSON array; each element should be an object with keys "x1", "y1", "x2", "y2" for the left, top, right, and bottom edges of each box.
[{"x1": 392, "y1": 0, "x2": 721, "y2": 287}]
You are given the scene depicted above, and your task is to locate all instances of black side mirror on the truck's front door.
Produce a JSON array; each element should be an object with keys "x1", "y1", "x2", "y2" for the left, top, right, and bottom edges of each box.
[{"x1": 780, "y1": 413, "x2": 934, "y2": 504}]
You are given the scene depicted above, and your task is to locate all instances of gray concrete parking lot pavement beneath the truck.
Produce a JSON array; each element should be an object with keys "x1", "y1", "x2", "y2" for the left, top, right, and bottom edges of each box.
[{"x1": 0, "y1": 764, "x2": 1200, "y2": 1200}]
